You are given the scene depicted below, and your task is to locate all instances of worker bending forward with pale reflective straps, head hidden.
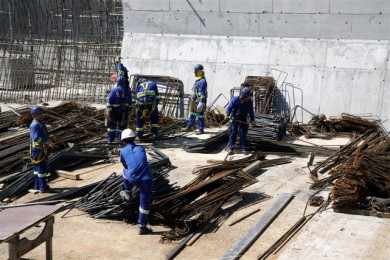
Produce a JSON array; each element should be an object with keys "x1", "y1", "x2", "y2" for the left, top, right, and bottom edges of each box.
[{"x1": 135, "y1": 79, "x2": 160, "y2": 138}]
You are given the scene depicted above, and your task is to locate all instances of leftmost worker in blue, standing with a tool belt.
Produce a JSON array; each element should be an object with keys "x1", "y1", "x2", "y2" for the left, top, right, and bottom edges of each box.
[{"x1": 30, "y1": 106, "x2": 49, "y2": 193}]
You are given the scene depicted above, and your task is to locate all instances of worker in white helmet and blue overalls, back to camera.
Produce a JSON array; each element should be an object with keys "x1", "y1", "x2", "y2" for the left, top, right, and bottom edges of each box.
[{"x1": 120, "y1": 129, "x2": 152, "y2": 235}]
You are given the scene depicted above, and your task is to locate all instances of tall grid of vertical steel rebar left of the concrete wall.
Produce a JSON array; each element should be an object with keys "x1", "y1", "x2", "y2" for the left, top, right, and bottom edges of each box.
[{"x1": 0, "y1": 0, "x2": 123, "y2": 103}]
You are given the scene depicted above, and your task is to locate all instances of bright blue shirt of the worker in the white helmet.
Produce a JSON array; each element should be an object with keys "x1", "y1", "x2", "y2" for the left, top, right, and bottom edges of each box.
[{"x1": 120, "y1": 143, "x2": 152, "y2": 182}]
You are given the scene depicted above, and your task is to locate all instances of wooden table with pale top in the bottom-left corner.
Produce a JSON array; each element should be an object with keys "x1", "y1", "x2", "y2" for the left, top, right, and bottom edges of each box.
[{"x1": 0, "y1": 205, "x2": 60, "y2": 260}]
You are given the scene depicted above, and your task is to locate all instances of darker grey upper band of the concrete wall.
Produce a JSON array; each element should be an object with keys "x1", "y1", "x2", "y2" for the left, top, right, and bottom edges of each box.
[{"x1": 123, "y1": 0, "x2": 390, "y2": 40}]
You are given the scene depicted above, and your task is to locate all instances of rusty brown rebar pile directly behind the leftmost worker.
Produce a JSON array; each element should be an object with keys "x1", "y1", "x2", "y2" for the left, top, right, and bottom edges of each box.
[{"x1": 0, "y1": 102, "x2": 105, "y2": 175}]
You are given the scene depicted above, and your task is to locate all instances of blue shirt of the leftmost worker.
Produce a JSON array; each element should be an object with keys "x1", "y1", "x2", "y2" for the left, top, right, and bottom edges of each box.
[{"x1": 30, "y1": 119, "x2": 49, "y2": 164}]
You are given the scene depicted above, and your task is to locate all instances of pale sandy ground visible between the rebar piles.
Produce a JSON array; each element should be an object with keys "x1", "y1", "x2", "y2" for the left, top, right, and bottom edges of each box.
[{"x1": 0, "y1": 129, "x2": 390, "y2": 260}]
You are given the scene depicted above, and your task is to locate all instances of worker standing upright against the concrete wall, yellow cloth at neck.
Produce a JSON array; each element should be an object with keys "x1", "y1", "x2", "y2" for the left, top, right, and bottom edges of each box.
[{"x1": 186, "y1": 64, "x2": 207, "y2": 134}]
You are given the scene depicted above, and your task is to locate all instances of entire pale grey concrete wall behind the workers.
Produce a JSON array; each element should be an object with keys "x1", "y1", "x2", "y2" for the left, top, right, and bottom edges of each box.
[{"x1": 122, "y1": 0, "x2": 390, "y2": 127}]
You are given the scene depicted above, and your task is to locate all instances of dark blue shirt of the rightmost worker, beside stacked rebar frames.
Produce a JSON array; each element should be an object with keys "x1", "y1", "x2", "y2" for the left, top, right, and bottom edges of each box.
[{"x1": 226, "y1": 97, "x2": 255, "y2": 122}]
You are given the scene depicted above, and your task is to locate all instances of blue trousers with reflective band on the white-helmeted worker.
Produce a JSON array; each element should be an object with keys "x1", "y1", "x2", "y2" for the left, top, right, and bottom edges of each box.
[{"x1": 123, "y1": 179, "x2": 152, "y2": 227}]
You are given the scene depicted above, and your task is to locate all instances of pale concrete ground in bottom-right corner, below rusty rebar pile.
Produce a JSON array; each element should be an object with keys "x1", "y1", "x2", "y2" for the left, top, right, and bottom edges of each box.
[{"x1": 278, "y1": 211, "x2": 390, "y2": 260}]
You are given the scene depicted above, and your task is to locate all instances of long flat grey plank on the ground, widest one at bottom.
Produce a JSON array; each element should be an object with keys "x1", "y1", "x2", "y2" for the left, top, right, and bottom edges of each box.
[{"x1": 221, "y1": 193, "x2": 294, "y2": 260}]
